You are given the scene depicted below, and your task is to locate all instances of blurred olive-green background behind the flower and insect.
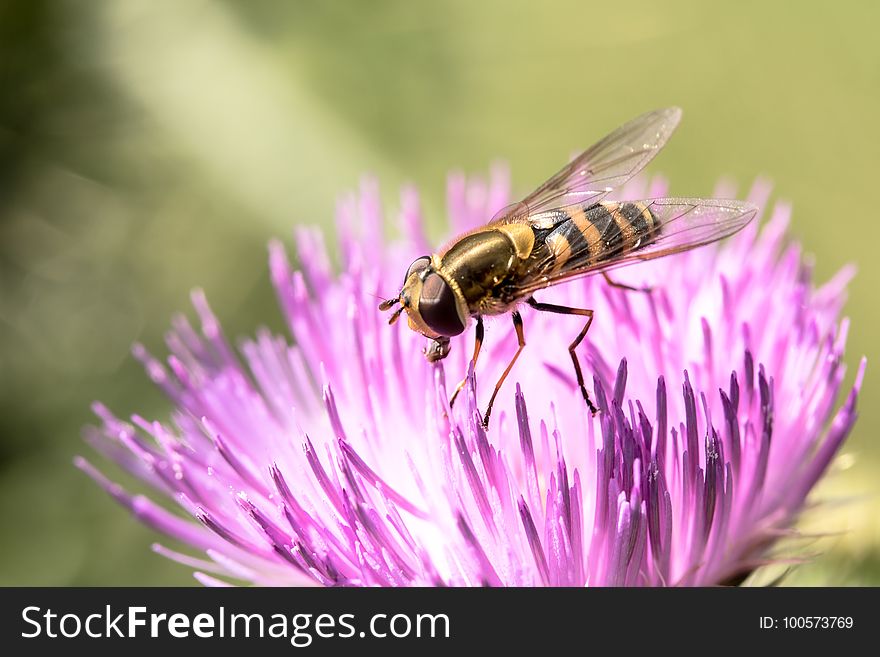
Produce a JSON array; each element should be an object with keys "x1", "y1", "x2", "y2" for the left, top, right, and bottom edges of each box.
[{"x1": 0, "y1": 0, "x2": 880, "y2": 585}]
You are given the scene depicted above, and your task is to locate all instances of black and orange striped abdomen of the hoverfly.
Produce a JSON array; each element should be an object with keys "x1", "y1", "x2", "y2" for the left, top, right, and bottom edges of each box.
[{"x1": 544, "y1": 201, "x2": 660, "y2": 273}]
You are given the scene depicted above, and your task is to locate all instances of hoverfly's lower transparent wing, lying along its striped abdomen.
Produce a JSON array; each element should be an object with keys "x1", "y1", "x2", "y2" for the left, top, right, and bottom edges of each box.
[{"x1": 512, "y1": 198, "x2": 758, "y2": 297}]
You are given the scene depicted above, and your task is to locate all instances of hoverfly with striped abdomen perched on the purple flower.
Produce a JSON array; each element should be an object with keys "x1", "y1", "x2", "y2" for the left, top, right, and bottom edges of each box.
[{"x1": 379, "y1": 107, "x2": 757, "y2": 426}]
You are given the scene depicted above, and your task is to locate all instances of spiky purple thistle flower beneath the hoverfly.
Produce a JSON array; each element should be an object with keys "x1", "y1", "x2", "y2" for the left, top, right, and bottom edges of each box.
[{"x1": 77, "y1": 170, "x2": 865, "y2": 586}]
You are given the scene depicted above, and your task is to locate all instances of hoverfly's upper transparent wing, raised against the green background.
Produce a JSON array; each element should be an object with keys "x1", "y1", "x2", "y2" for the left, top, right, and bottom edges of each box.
[{"x1": 492, "y1": 107, "x2": 681, "y2": 223}]
